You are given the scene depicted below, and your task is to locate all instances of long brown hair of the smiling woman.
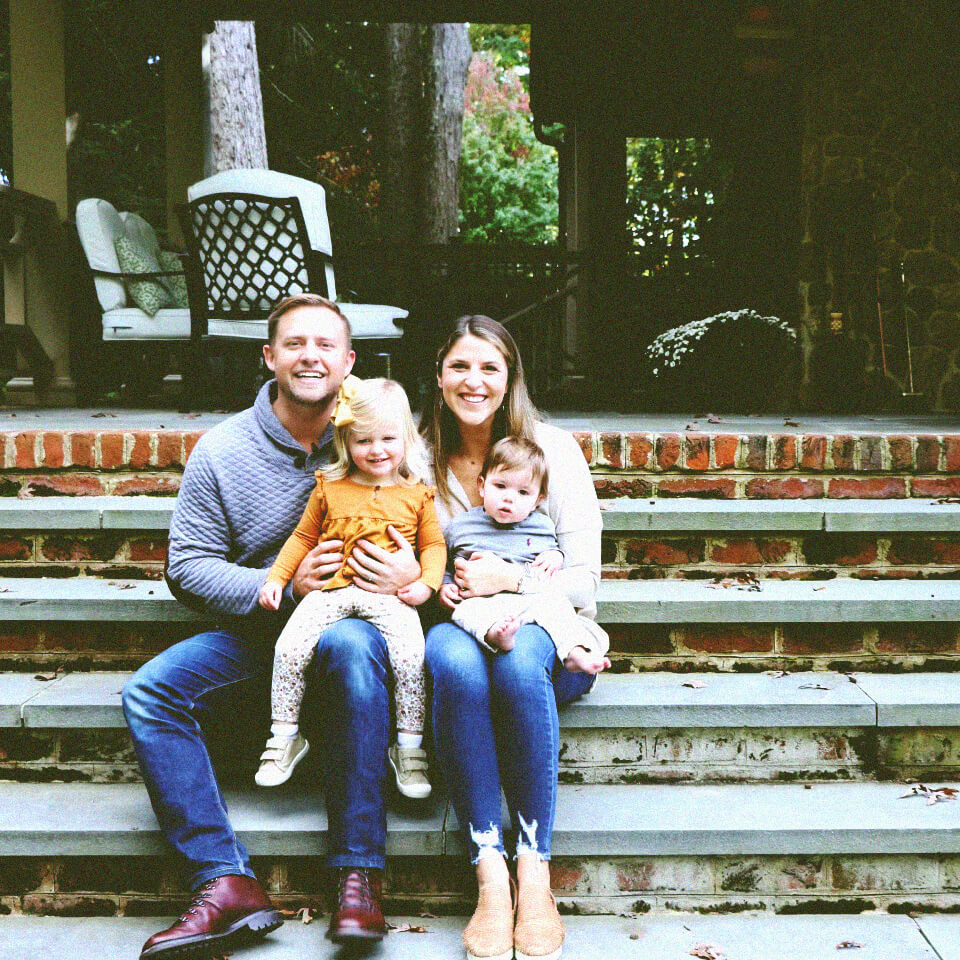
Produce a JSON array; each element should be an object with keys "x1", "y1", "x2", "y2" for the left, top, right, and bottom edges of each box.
[{"x1": 420, "y1": 314, "x2": 540, "y2": 504}]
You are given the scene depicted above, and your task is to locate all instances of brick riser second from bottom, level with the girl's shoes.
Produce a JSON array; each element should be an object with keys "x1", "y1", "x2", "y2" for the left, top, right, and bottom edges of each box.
[{"x1": 0, "y1": 727, "x2": 960, "y2": 785}]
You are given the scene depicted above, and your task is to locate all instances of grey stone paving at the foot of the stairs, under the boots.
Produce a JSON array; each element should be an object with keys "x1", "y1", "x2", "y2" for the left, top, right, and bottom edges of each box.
[{"x1": 0, "y1": 913, "x2": 948, "y2": 960}]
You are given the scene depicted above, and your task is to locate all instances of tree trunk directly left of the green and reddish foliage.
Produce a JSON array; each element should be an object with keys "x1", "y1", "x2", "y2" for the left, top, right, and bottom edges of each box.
[{"x1": 420, "y1": 23, "x2": 473, "y2": 243}]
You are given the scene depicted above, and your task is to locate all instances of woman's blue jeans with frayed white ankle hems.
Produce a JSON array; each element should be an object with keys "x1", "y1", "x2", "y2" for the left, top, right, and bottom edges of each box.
[{"x1": 426, "y1": 623, "x2": 594, "y2": 863}]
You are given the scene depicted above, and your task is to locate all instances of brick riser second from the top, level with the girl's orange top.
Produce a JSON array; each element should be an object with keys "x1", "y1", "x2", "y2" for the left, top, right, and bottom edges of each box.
[{"x1": 0, "y1": 530, "x2": 960, "y2": 580}]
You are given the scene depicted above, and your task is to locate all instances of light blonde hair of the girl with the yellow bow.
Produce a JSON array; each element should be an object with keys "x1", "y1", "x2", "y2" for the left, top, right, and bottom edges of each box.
[{"x1": 323, "y1": 377, "x2": 429, "y2": 486}]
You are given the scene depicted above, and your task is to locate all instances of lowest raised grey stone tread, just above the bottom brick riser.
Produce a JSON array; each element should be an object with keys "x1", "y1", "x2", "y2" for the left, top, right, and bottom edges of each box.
[{"x1": 0, "y1": 782, "x2": 960, "y2": 857}]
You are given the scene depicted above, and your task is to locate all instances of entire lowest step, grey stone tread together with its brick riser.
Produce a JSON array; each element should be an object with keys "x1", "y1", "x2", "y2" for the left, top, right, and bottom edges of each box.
[{"x1": 0, "y1": 783, "x2": 960, "y2": 923}]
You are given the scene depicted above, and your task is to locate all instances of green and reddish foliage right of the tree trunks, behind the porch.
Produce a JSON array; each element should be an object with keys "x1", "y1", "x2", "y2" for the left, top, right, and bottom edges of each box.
[{"x1": 460, "y1": 53, "x2": 558, "y2": 243}]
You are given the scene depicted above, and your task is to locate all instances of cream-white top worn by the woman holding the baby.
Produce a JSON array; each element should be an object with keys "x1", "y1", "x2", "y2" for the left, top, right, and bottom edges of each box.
[{"x1": 436, "y1": 423, "x2": 603, "y2": 620}]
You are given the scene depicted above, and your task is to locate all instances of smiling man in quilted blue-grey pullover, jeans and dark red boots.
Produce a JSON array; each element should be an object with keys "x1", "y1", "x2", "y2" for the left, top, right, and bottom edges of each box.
[{"x1": 123, "y1": 293, "x2": 420, "y2": 960}]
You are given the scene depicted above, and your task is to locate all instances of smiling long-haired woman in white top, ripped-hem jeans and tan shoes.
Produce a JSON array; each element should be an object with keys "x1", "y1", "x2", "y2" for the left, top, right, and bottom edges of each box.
[{"x1": 421, "y1": 316, "x2": 605, "y2": 960}]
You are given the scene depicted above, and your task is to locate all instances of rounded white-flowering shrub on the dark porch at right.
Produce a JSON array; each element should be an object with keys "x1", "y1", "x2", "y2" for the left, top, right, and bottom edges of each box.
[{"x1": 645, "y1": 310, "x2": 800, "y2": 411}]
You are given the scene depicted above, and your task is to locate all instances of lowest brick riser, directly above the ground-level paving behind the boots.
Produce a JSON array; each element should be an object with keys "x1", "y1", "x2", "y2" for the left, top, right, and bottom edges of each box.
[{"x1": 0, "y1": 854, "x2": 960, "y2": 923}]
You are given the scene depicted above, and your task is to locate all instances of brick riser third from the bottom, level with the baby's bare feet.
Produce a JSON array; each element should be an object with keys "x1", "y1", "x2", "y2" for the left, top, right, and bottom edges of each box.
[{"x1": 0, "y1": 621, "x2": 960, "y2": 673}]
